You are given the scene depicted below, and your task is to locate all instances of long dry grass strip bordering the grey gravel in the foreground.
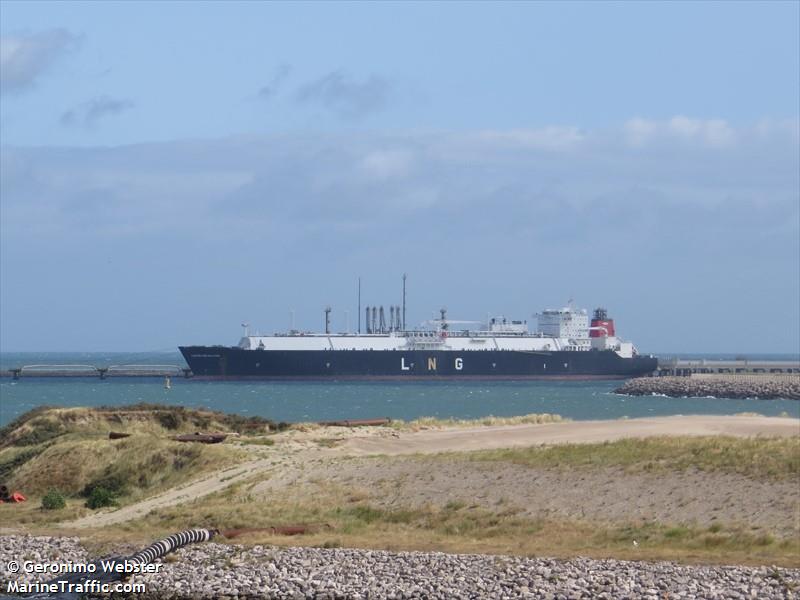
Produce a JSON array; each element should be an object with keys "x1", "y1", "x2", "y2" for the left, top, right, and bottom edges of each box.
[{"x1": 65, "y1": 481, "x2": 800, "y2": 567}]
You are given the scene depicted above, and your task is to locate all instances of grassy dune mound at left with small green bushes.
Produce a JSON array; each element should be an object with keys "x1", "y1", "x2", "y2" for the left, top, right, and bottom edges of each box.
[{"x1": 0, "y1": 407, "x2": 247, "y2": 526}]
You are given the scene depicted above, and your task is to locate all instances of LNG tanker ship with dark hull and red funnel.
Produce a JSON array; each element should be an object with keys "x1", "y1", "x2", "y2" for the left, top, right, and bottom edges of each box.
[{"x1": 180, "y1": 305, "x2": 657, "y2": 380}]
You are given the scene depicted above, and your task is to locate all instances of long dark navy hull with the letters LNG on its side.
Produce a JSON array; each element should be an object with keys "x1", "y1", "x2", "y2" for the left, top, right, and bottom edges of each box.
[{"x1": 180, "y1": 346, "x2": 658, "y2": 381}]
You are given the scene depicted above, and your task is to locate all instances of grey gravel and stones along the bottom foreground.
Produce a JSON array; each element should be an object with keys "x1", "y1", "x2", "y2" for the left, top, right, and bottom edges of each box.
[{"x1": 0, "y1": 536, "x2": 800, "y2": 600}]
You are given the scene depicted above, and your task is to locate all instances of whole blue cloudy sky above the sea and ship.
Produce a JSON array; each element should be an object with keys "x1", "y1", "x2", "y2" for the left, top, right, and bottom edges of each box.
[{"x1": 0, "y1": 1, "x2": 800, "y2": 352}]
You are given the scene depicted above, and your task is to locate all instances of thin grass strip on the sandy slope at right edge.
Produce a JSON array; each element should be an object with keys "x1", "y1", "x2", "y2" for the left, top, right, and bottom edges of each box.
[{"x1": 456, "y1": 436, "x2": 800, "y2": 480}]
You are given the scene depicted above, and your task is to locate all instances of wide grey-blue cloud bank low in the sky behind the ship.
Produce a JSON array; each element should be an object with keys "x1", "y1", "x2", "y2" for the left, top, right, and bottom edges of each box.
[{"x1": 0, "y1": 118, "x2": 800, "y2": 350}]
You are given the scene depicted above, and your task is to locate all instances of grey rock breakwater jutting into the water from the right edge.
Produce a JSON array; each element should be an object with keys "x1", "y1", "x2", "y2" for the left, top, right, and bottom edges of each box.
[{"x1": 614, "y1": 374, "x2": 800, "y2": 400}]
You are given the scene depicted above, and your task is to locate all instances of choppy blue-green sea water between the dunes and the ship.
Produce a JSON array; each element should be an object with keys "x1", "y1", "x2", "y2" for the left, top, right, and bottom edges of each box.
[{"x1": 0, "y1": 353, "x2": 800, "y2": 425}]
